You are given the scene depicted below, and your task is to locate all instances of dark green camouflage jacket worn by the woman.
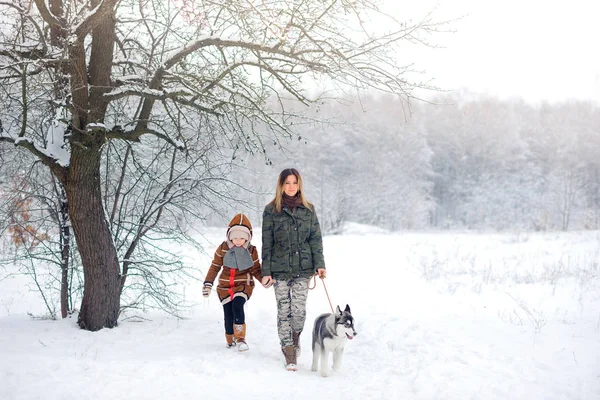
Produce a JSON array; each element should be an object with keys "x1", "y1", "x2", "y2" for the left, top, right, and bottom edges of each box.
[{"x1": 261, "y1": 204, "x2": 325, "y2": 279}]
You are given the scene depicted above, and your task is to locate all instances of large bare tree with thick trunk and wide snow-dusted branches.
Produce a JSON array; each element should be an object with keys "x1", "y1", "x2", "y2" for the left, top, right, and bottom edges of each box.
[{"x1": 0, "y1": 0, "x2": 440, "y2": 330}]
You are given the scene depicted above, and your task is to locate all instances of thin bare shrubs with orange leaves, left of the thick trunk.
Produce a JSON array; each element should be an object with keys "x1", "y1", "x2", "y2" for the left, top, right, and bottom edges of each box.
[{"x1": 0, "y1": 162, "x2": 81, "y2": 318}]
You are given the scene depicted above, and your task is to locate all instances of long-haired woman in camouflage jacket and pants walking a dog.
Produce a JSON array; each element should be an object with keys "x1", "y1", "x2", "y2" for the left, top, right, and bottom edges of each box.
[{"x1": 262, "y1": 168, "x2": 326, "y2": 371}]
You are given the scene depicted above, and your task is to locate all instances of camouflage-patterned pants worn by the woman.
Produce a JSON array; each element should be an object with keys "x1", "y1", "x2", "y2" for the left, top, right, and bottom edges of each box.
[{"x1": 273, "y1": 278, "x2": 309, "y2": 348}]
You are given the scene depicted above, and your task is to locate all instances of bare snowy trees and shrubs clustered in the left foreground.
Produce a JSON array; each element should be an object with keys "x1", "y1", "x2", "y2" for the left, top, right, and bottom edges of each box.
[{"x1": 0, "y1": 0, "x2": 464, "y2": 331}]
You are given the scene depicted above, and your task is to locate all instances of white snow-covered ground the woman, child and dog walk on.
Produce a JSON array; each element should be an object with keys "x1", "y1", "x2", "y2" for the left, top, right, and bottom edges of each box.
[{"x1": 0, "y1": 225, "x2": 600, "y2": 400}]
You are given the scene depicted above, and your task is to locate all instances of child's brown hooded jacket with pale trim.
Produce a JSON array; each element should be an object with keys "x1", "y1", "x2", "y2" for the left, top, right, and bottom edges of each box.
[{"x1": 204, "y1": 214, "x2": 262, "y2": 304}]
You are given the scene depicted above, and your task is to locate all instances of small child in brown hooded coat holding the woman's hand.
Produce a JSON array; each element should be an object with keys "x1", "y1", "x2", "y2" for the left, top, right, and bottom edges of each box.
[{"x1": 202, "y1": 214, "x2": 262, "y2": 351}]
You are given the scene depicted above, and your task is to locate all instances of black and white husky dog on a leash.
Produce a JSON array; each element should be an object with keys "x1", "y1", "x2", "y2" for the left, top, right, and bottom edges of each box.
[{"x1": 311, "y1": 304, "x2": 356, "y2": 377}]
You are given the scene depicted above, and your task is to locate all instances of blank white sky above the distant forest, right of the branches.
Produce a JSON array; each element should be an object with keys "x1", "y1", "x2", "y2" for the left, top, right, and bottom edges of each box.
[{"x1": 394, "y1": 0, "x2": 600, "y2": 104}]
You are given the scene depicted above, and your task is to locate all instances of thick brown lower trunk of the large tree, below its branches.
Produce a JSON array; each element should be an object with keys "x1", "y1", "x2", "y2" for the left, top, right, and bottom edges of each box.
[{"x1": 65, "y1": 143, "x2": 120, "y2": 331}]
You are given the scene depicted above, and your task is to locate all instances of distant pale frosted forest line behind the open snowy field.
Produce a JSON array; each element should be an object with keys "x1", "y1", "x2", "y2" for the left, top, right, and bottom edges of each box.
[{"x1": 221, "y1": 92, "x2": 600, "y2": 232}]
